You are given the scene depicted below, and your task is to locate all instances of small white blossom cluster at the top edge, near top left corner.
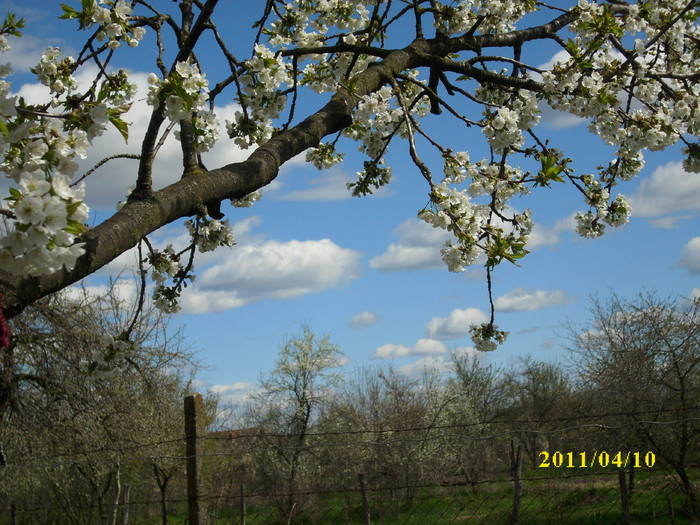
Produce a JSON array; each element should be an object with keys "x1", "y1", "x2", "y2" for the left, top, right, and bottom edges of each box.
[{"x1": 61, "y1": 0, "x2": 146, "y2": 49}]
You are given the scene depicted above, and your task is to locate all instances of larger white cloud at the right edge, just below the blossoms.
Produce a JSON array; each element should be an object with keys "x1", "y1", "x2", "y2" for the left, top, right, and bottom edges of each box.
[{"x1": 630, "y1": 162, "x2": 700, "y2": 221}]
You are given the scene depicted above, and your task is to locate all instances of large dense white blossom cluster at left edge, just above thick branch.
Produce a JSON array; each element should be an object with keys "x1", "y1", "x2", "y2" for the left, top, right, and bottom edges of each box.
[{"x1": 0, "y1": 101, "x2": 89, "y2": 275}]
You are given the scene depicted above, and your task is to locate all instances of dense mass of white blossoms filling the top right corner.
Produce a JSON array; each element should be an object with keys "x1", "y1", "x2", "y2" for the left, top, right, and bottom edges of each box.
[{"x1": 543, "y1": 0, "x2": 700, "y2": 179}]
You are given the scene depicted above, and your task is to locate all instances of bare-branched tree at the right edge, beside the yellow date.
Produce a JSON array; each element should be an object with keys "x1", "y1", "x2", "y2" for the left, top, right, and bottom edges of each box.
[{"x1": 570, "y1": 292, "x2": 700, "y2": 517}]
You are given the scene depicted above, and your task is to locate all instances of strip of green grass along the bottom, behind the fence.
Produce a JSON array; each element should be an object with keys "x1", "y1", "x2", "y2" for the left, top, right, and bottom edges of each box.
[{"x1": 156, "y1": 470, "x2": 698, "y2": 525}]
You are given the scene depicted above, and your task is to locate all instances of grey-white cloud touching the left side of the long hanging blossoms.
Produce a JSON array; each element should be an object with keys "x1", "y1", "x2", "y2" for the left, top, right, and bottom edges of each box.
[{"x1": 369, "y1": 219, "x2": 449, "y2": 272}]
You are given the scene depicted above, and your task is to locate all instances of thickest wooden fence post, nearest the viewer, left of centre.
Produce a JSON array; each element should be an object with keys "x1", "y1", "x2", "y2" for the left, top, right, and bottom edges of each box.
[{"x1": 185, "y1": 393, "x2": 206, "y2": 525}]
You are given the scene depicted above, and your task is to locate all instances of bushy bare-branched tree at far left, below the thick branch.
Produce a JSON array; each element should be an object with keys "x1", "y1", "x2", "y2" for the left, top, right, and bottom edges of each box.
[{"x1": 0, "y1": 287, "x2": 202, "y2": 524}]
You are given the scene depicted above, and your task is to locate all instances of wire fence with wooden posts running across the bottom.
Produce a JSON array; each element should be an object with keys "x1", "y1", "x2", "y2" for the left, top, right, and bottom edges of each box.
[{"x1": 0, "y1": 400, "x2": 700, "y2": 525}]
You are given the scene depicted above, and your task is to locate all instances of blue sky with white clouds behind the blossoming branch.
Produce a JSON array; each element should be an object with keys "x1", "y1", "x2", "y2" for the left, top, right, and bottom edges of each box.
[{"x1": 0, "y1": 1, "x2": 700, "y2": 406}]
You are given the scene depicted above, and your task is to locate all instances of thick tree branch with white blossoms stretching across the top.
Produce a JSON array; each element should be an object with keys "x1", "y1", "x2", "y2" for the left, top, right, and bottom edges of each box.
[{"x1": 0, "y1": 0, "x2": 700, "y2": 350}]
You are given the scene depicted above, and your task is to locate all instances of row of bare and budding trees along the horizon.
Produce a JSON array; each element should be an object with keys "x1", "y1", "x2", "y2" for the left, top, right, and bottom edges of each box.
[{"x1": 0, "y1": 292, "x2": 700, "y2": 524}]
